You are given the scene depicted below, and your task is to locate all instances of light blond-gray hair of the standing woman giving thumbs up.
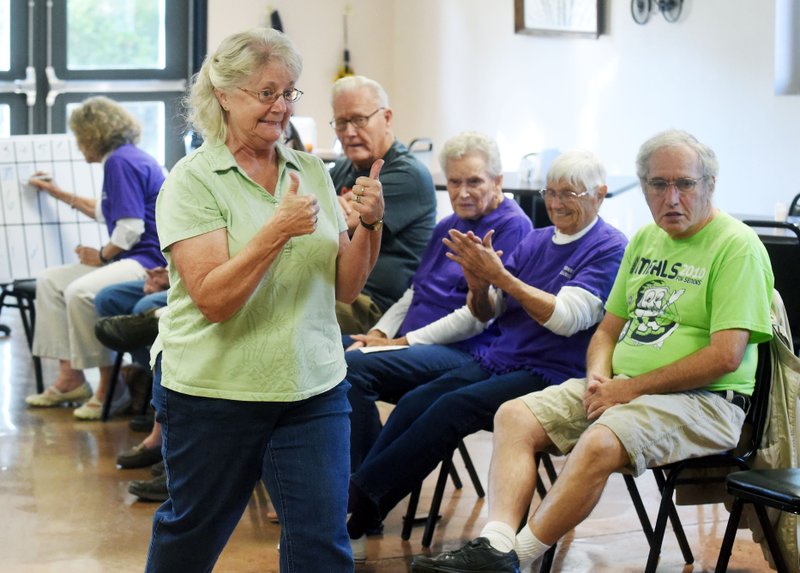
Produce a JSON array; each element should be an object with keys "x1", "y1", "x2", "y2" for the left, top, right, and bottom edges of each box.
[{"x1": 185, "y1": 28, "x2": 303, "y2": 141}]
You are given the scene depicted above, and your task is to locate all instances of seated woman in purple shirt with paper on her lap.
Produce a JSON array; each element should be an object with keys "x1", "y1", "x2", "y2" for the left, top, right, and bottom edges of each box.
[{"x1": 345, "y1": 132, "x2": 533, "y2": 471}]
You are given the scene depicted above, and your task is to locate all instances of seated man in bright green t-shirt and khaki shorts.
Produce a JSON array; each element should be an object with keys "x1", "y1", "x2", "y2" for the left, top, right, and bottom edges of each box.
[{"x1": 412, "y1": 130, "x2": 773, "y2": 573}]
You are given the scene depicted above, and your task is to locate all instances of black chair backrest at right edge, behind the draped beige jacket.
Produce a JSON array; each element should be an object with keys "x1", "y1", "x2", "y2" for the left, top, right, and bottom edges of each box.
[{"x1": 744, "y1": 220, "x2": 800, "y2": 347}]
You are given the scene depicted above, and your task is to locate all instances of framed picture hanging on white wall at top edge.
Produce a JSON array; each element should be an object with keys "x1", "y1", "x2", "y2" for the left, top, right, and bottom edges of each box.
[{"x1": 514, "y1": 0, "x2": 603, "y2": 38}]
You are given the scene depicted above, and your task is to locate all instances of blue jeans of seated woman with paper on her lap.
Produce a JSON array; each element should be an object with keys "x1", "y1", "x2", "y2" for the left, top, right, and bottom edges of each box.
[{"x1": 345, "y1": 344, "x2": 472, "y2": 472}]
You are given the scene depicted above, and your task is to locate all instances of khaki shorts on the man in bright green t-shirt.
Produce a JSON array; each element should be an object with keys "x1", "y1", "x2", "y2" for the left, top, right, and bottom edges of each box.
[{"x1": 520, "y1": 378, "x2": 745, "y2": 476}]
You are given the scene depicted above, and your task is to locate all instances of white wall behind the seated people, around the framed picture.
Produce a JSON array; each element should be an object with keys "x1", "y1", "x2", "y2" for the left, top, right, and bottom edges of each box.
[{"x1": 209, "y1": 0, "x2": 800, "y2": 215}]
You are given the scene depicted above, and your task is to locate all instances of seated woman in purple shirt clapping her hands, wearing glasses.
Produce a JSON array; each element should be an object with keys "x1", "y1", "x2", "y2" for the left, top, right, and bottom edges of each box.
[{"x1": 347, "y1": 151, "x2": 627, "y2": 559}]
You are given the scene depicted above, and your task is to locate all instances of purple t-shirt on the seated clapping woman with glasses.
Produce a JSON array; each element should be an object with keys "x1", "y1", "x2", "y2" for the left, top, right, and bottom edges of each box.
[{"x1": 473, "y1": 219, "x2": 628, "y2": 384}]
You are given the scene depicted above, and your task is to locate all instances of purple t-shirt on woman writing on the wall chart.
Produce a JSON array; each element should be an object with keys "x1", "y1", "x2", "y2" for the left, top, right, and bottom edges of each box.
[{"x1": 101, "y1": 143, "x2": 167, "y2": 269}]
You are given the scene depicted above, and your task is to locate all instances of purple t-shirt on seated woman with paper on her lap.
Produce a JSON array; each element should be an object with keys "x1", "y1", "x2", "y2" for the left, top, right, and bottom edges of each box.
[{"x1": 398, "y1": 199, "x2": 533, "y2": 350}]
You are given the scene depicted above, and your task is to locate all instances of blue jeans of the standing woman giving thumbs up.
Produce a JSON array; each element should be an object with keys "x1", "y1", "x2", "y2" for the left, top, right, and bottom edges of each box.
[{"x1": 145, "y1": 356, "x2": 354, "y2": 573}]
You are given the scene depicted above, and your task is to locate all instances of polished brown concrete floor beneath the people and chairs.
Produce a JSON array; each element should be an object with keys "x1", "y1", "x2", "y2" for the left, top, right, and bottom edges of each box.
[{"x1": 0, "y1": 309, "x2": 770, "y2": 573}]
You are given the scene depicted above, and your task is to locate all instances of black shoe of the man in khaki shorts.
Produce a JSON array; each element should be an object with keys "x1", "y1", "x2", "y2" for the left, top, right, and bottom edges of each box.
[{"x1": 411, "y1": 537, "x2": 519, "y2": 573}]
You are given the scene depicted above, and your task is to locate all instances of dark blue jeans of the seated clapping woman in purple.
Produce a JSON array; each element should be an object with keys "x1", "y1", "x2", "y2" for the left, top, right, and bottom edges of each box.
[{"x1": 350, "y1": 362, "x2": 549, "y2": 522}]
